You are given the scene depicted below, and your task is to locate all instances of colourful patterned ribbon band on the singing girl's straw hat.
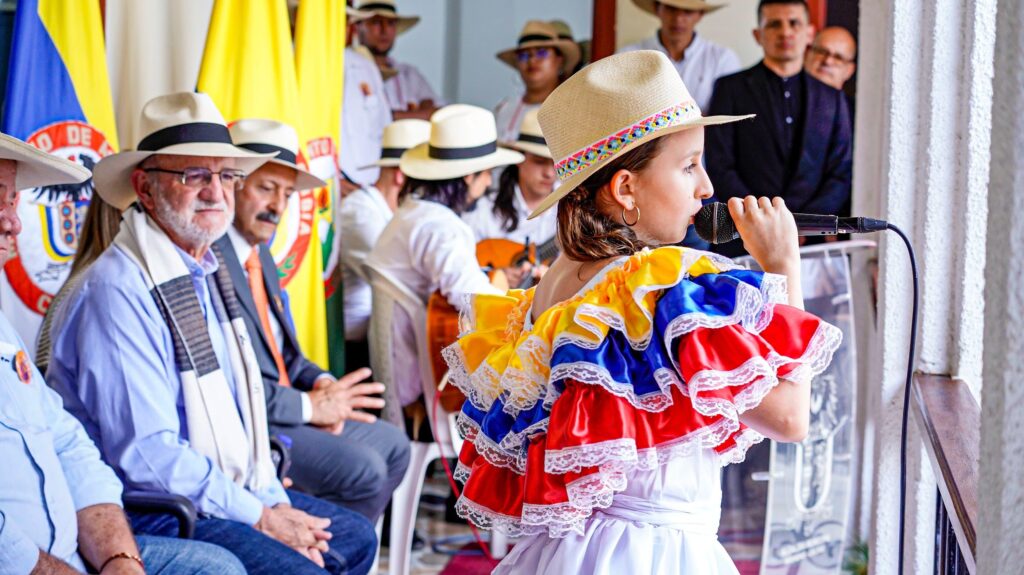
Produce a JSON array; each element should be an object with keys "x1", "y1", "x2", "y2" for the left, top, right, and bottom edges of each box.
[{"x1": 555, "y1": 100, "x2": 700, "y2": 181}]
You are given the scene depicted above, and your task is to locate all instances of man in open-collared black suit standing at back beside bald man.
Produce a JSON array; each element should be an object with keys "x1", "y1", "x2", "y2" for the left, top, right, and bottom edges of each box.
[{"x1": 706, "y1": 0, "x2": 853, "y2": 256}]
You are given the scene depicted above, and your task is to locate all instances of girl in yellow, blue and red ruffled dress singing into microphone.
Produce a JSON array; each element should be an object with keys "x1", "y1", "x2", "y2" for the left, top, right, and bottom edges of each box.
[{"x1": 445, "y1": 51, "x2": 842, "y2": 575}]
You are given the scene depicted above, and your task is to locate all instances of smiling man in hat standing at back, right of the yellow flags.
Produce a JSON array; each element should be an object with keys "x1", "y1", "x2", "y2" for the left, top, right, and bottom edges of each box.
[{"x1": 356, "y1": 0, "x2": 443, "y2": 120}]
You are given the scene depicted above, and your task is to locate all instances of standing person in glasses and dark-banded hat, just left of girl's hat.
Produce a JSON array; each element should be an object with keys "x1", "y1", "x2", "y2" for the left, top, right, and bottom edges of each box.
[{"x1": 495, "y1": 20, "x2": 580, "y2": 142}]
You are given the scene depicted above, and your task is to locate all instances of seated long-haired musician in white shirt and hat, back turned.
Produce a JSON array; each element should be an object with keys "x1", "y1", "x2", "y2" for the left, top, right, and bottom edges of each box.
[{"x1": 367, "y1": 104, "x2": 523, "y2": 406}]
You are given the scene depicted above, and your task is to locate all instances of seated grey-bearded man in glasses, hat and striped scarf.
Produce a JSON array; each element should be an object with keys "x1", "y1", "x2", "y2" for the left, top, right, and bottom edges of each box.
[{"x1": 47, "y1": 92, "x2": 376, "y2": 574}]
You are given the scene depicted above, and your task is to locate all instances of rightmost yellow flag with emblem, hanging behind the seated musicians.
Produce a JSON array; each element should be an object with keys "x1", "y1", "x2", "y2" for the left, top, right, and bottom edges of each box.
[{"x1": 295, "y1": 0, "x2": 345, "y2": 375}]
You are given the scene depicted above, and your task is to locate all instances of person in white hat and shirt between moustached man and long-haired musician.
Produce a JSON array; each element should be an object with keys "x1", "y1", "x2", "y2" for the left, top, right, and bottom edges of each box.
[{"x1": 338, "y1": 119, "x2": 430, "y2": 368}]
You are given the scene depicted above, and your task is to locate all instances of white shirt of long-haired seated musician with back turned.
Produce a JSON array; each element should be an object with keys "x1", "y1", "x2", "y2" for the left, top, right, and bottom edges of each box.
[{"x1": 367, "y1": 197, "x2": 500, "y2": 406}]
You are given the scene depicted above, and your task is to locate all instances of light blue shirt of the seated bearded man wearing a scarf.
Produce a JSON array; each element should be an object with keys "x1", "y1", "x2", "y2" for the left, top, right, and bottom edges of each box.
[{"x1": 46, "y1": 246, "x2": 289, "y2": 525}]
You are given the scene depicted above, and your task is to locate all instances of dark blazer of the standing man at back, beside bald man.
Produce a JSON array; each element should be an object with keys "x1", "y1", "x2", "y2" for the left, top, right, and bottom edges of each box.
[{"x1": 705, "y1": 62, "x2": 853, "y2": 246}]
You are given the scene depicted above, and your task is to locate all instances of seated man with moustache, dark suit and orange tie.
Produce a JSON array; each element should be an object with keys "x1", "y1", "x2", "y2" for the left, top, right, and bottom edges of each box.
[{"x1": 215, "y1": 120, "x2": 409, "y2": 521}]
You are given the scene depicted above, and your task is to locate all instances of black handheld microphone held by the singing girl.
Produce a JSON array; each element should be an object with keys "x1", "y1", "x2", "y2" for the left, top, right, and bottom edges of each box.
[{"x1": 693, "y1": 202, "x2": 889, "y2": 244}]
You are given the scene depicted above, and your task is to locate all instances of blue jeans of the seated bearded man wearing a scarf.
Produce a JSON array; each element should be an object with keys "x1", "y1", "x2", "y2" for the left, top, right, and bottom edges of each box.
[{"x1": 128, "y1": 490, "x2": 377, "y2": 575}]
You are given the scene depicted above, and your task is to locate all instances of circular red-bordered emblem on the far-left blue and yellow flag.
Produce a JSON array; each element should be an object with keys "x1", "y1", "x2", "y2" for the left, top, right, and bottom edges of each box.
[{"x1": 4, "y1": 120, "x2": 114, "y2": 315}]
